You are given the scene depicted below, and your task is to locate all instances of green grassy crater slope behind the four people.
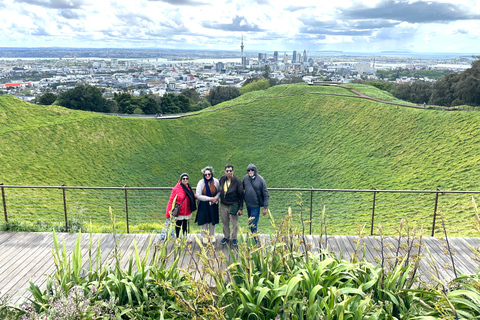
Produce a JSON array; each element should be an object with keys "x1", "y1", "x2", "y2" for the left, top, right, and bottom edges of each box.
[{"x1": 0, "y1": 84, "x2": 480, "y2": 235}]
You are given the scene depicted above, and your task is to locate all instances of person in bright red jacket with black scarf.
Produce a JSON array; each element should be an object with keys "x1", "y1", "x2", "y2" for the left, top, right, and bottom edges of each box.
[{"x1": 165, "y1": 173, "x2": 197, "y2": 243}]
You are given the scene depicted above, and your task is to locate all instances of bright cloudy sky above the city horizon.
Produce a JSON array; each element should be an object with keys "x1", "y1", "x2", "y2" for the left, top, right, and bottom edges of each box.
[{"x1": 0, "y1": 0, "x2": 480, "y2": 53}]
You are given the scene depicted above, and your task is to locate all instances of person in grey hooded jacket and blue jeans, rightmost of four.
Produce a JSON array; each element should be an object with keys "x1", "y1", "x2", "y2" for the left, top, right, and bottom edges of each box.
[{"x1": 242, "y1": 163, "x2": 270, "y2": 242}]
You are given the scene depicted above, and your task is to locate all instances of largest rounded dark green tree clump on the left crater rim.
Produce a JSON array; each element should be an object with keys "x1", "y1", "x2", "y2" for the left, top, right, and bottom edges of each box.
[{"x1": 58, "y1": 84, "x2": 108, "y2": 112}]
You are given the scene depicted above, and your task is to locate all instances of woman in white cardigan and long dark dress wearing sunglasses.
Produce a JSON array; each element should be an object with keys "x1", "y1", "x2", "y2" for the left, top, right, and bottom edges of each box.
[{"x1": 195, "y1": 166, "x2": 220, "y2": 243}]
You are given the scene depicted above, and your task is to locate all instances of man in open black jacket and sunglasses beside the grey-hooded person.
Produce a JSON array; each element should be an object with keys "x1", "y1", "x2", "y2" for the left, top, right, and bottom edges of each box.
[{"x1": 220, "y1": 164, "x2": 243, "y2": 246}]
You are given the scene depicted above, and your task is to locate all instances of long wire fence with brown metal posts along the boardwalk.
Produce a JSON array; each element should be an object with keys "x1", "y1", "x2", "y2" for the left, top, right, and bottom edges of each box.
[{"x1": 0, "y1": 183, "x2": 480, "y2": 236}]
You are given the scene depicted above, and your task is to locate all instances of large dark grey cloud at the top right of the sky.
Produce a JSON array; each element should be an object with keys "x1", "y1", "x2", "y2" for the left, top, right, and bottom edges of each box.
[{"x1": 340, "y1": 0, "x2": 480, "y2": 23}]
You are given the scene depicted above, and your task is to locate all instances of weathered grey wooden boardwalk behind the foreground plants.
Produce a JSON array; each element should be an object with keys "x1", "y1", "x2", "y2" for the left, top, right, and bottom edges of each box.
[{"x1": 0, "y1": 232, "x2": 480, "y2": 302}]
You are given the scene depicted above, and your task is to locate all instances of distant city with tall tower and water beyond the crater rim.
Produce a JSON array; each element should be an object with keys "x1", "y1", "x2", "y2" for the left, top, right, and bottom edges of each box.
[{"x1": 0, "y1": 45, "x2": 474, "y2": 103}]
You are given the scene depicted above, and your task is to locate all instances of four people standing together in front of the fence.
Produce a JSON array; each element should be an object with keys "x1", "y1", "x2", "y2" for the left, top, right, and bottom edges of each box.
[{"x1": 166, "y1": 163, "x2": 269, "y2": 246}]
